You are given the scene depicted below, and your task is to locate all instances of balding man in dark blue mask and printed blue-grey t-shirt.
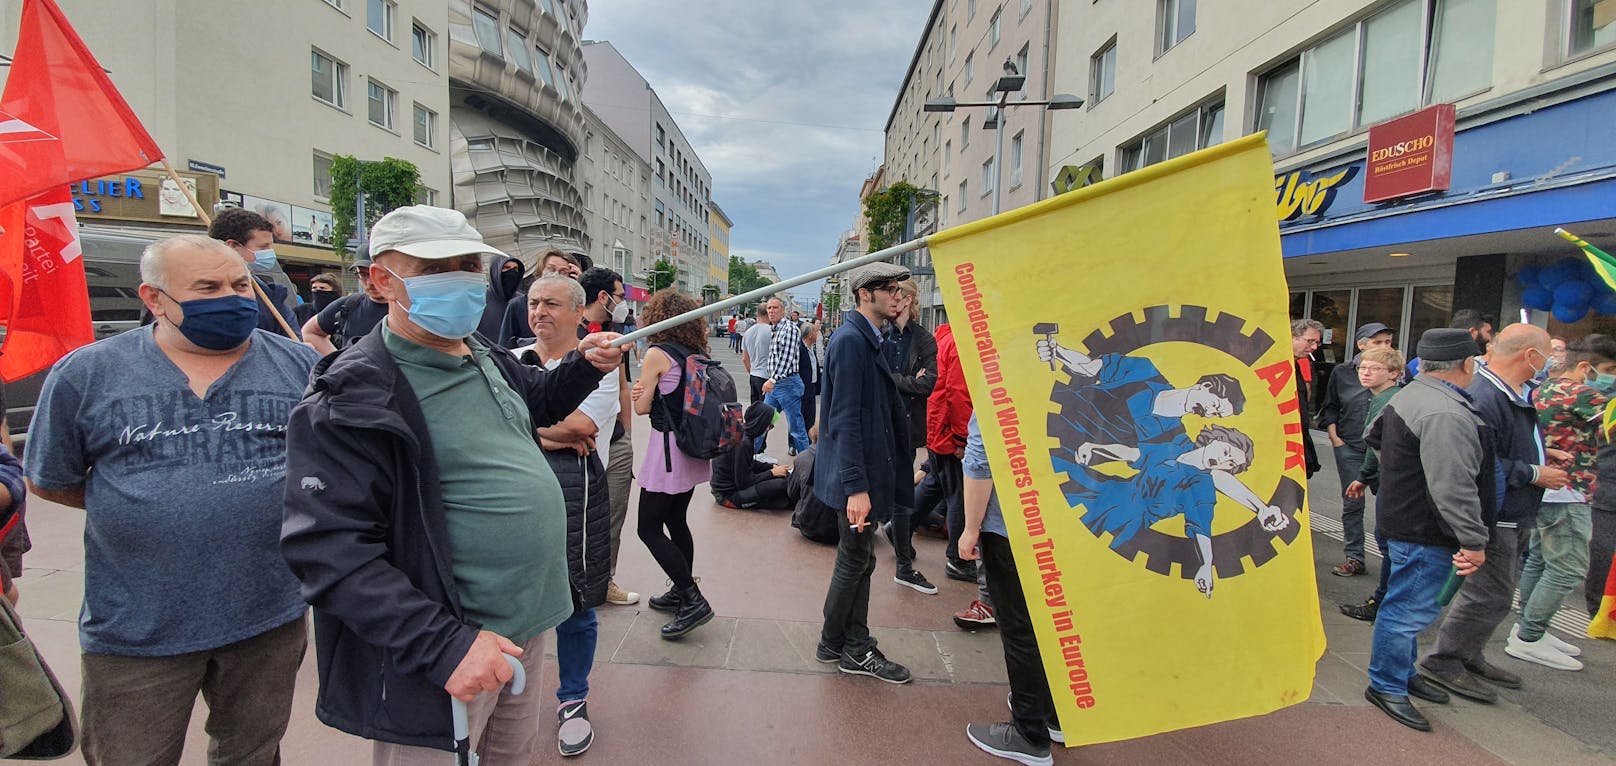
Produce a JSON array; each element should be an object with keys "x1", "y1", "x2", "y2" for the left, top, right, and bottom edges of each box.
[{"x1": 27, "y1": 234, "x2": 318, "y2": 764}]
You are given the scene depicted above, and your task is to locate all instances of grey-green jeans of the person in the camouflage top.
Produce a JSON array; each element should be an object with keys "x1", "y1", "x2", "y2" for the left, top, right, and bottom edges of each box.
[{"x1": 1521, "y1": 503, "x2": 1593, "y2": 642}]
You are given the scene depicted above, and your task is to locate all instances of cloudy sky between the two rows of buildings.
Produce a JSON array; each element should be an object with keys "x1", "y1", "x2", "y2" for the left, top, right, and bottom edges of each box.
[{"x1": 583, "y1": 0, "x2": 932, "y2": 305}]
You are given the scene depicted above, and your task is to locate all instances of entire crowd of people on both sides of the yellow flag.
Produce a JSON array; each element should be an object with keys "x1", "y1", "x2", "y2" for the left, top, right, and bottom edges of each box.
[{"x1": 0, "y1": 205, "x2": 1616, "y2": 764}]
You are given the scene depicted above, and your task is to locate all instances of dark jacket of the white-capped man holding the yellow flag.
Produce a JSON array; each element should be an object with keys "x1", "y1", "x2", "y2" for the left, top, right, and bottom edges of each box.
[{"x1": 281, "y1": 331, "x2": 601, "y2": 750}]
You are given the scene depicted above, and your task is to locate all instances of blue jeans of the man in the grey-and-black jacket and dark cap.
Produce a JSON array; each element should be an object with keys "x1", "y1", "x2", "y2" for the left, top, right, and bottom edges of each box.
[{"x1": 1369, "y1": 540, "x2": 1454, "y2": 697}]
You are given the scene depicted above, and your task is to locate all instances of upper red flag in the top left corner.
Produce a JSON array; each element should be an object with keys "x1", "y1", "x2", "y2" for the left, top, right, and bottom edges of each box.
[{"x1": 0, "y1": 0, "x2": 163, "y2": 208}]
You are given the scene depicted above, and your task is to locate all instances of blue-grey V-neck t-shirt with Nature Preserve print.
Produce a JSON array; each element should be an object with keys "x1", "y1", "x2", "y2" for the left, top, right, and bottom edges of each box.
[{"x1": 26, "y1": 326, "x2": 318, "y2": 656}]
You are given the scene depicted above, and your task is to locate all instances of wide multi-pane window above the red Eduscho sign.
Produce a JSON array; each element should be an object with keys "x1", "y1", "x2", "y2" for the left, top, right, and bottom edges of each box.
[{"x1": 1256, "y1": 0, "x2": 1496, "y2": 157}]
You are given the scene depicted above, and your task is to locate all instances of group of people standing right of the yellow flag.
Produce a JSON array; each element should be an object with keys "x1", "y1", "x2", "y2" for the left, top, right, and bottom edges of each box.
[{"x1": 1291, "y1": 310, "x2": 1616, "y2": 730}]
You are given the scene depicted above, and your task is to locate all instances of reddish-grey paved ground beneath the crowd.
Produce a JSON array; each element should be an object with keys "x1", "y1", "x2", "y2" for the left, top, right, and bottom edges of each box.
[{"x1": 6, "y1": 346, "x2": 1616, "y2": 766}]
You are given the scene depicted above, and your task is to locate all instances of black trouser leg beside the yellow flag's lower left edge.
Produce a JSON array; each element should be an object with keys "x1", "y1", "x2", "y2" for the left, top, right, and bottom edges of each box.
[{"x1": 978, "y1": 532, "x2": 1055, "y2": 747}]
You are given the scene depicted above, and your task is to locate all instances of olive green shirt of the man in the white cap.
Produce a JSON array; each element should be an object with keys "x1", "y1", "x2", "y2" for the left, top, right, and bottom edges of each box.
[{"x1": 383, "y1": 323, "x2": 572, "y2": 645}]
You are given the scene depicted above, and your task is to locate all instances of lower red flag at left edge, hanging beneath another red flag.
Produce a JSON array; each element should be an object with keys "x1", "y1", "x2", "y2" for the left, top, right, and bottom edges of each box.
[{"x1": 0, "y1": 186, "x2": 95, "y2": 383}]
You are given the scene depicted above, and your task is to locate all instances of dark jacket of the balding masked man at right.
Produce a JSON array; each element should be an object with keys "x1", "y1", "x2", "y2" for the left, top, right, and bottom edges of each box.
[{"x1": 1473, "y1": 362, "x2": 1548, "y2": 525}]
